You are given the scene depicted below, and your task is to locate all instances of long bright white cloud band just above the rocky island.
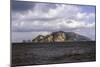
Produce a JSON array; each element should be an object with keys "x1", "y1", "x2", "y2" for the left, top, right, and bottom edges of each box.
[{"x1": 11, "y1": 19, "x2": 95, "y2": 32}]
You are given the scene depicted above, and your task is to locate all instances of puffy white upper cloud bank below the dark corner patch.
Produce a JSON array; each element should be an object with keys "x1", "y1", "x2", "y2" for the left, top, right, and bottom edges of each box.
[{"x1": 12, "y1": 4, "x2": 80, "y2": 20}]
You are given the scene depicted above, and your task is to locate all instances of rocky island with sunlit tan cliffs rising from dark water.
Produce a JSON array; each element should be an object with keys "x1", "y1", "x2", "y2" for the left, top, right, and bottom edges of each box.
[{"x1": 32, "y1": 31, "x2": 91, "y2": 42}]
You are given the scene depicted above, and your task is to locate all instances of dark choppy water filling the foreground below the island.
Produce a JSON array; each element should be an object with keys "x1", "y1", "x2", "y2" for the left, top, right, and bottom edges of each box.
[{"x1": 12, "y1": 41, "x2": 96, "y2": 66}]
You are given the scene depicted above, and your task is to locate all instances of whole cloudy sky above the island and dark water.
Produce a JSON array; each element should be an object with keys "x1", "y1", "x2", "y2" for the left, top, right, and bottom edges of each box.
[{"x1": 11, "y1": 1, "x2": 95, "y2": 42}]
